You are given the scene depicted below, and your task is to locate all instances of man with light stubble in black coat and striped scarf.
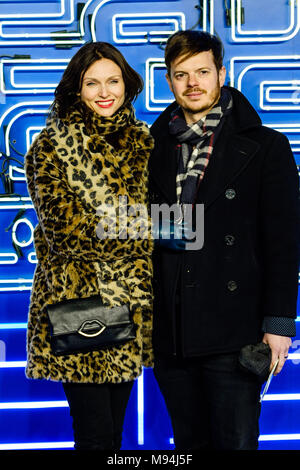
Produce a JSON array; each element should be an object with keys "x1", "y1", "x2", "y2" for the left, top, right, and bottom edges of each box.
[{"x1": 149, "y1": 31, "x2": 299, "y2": 450}]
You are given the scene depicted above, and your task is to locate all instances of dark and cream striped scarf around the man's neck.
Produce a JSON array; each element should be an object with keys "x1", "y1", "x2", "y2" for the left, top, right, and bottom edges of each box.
[{"x1": 169, "y1": 88, "x2": 232, "y2": 205}]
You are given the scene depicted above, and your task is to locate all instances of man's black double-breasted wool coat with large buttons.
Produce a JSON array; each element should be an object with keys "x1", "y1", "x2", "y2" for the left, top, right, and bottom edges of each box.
[{"x1": 149, "y1": 87, "x2": 299, "y2": 357}]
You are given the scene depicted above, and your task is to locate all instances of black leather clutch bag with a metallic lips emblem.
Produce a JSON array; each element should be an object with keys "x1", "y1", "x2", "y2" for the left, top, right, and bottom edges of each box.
[{"x1": 47, "y1": 295, "x2": 135, "y2": 355}]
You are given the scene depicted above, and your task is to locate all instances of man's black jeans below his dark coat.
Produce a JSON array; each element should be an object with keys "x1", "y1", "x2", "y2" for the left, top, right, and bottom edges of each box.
[{"x1": 154, "y1": 354, "x2": 262, "y2": 450}]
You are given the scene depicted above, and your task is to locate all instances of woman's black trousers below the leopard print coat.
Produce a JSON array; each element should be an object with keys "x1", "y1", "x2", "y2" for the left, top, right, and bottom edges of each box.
[{"x1": 63, "y1": 382, "x2": 133, "y2": 450}]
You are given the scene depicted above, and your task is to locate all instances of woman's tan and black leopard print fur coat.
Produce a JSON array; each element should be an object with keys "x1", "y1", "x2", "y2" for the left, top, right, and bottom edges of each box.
[{"x1": 25, "y1": 106, "x2": 153, "y2": 383}]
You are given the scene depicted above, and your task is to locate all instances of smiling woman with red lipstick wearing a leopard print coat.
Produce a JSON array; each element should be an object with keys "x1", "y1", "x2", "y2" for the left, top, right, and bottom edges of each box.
[{"x1": 25, "y1": 42, "x2": 153, "y2": 449}]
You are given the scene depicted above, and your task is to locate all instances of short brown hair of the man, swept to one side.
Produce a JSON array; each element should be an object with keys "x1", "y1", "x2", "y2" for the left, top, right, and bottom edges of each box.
[{"x1": 165, "y1": 29, "x2": 224, "y2": 75}]
